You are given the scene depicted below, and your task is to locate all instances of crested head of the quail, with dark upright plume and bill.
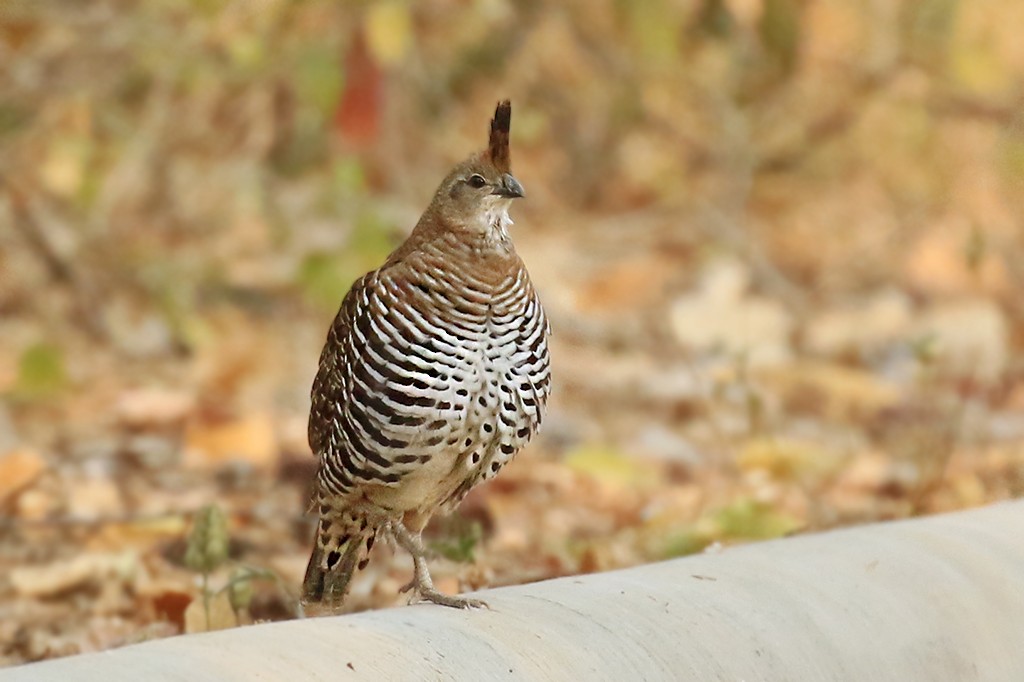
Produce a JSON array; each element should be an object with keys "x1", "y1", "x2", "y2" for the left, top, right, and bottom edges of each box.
[{"x1": 419, "y1": 99, "x2": 524, "y2": 240}]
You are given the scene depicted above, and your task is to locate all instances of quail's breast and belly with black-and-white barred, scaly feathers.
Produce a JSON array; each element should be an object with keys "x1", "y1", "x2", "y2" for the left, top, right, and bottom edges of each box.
[{"x1": 327, "y1": 261, "x2": 547, "y2": 511}]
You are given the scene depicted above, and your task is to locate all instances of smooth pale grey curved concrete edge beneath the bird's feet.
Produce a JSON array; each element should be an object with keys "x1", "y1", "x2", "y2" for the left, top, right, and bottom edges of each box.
[{"x1": 0, "y1": 502, "x2": 1024, "y2": 682}]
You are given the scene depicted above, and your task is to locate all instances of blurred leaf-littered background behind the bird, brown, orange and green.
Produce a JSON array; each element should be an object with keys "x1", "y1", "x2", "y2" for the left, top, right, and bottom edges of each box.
[{"x1": 0, "y1": 0, "x2": 1024, "y2": 665}]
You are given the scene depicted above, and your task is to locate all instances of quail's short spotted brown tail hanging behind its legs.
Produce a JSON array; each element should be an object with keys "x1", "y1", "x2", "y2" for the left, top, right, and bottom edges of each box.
[{"x1": 302, "y1": 512, "x2": 377, "y2": 604}]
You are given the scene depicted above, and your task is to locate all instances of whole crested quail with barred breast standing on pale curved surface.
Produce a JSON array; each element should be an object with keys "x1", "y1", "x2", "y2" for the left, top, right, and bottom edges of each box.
[{"x1": 302, "y1": 99, "x2": 551, "y2": 608}]
